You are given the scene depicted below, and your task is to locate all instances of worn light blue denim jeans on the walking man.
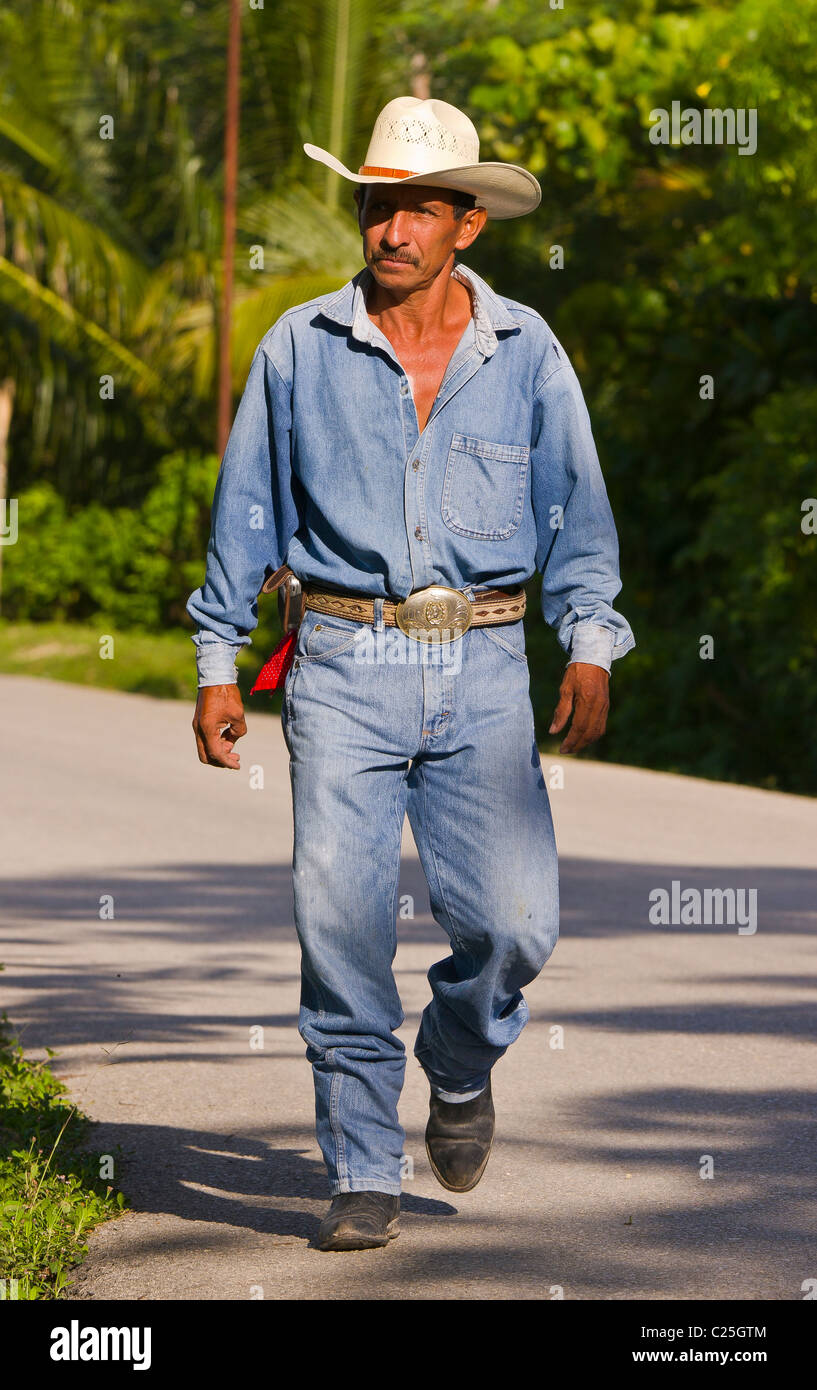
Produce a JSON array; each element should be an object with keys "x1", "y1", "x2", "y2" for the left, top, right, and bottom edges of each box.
[{"x1": 282, "y1": 599, "x2": 559, "y2": 1195}]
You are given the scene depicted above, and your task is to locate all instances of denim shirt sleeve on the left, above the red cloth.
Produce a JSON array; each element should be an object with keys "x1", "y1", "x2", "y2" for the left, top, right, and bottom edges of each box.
[{"x1": 186, "y1": 339, "x2": 299, "y2": 685}]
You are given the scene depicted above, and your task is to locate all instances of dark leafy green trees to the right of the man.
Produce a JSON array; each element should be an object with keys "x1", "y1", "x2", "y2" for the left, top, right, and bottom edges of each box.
[{"x1": 391, "y1": 0, "x2": 817, "y2": 792}]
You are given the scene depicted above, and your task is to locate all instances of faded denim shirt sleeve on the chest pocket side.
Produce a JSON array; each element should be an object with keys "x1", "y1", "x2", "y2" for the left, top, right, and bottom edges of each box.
[{"x1": 531, "y1": 338, "x2": 635, "y2": 671}]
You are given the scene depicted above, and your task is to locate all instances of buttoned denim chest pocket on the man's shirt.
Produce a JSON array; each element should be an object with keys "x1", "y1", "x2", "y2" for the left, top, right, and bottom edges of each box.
[{"x1": 442, "y1": 434, "x2": 531, "y2": 541}]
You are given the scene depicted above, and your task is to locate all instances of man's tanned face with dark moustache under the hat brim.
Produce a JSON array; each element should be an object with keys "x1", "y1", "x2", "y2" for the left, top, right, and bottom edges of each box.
[{"x1": 354, "y1": 183, "x2": 488, "y2": 291}]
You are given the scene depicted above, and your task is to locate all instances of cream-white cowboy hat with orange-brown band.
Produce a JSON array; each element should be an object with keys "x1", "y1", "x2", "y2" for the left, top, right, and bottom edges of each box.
[{"x1": 304, "y1": 96, "x2": 542, "y2": 220}]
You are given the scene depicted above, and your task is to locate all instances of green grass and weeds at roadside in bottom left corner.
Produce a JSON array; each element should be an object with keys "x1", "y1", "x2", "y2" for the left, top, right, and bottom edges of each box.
[{"x1": 0, "y1": 1006, "x2": 125, "y2": 1300}]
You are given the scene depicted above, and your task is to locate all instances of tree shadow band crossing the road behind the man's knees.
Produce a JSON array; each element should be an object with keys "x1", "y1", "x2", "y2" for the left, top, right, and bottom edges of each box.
[{"x1": 0, "y1": 859, "x2": 817, "y2": 1061}]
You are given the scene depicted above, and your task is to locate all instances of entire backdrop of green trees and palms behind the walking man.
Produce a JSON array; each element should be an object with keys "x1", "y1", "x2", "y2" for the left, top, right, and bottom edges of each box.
[{"x1": 0, "y1": 0, "x2": 817, "y2": 792}]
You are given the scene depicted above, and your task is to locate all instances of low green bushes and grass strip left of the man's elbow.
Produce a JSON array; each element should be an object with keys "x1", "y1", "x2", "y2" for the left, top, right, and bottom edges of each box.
[{"x1": 0, "y1": 453, "x2": 281, "y2": 709}]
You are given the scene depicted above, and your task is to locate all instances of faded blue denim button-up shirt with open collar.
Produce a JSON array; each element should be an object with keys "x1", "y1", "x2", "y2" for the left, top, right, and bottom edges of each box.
[{"x1": 188, "y1": 263, "x2": 635, "y2": 685}]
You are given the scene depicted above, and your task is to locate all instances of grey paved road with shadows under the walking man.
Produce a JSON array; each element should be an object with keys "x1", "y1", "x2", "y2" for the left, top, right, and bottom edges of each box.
[{"x1": 0, "y1": 677, "x2": 817, "y2": 1300}]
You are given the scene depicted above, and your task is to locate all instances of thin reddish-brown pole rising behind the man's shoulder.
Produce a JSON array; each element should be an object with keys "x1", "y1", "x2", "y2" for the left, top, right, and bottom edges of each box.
[{"x1": 217, "y1": 0, "x2": 242, "y2": 457}]
